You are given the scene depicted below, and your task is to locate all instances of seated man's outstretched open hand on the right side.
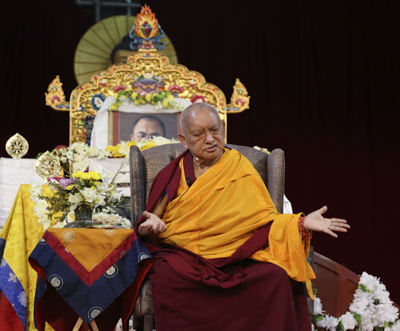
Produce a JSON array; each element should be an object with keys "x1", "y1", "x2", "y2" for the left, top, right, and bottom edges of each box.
[{"x1": 304, "y1": 206, "x2": 350, "y2": 238}]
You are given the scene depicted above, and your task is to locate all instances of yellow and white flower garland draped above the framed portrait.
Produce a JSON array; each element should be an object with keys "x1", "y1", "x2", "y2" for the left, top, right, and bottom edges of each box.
[{"x1": 111, "y1": 85, "x2": 183, "y2": 111}]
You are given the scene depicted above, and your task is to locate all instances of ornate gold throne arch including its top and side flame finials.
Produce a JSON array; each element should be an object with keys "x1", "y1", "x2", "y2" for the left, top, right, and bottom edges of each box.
[{"x1": 45, "y1": 5, "x2": 250, "y2": 144}]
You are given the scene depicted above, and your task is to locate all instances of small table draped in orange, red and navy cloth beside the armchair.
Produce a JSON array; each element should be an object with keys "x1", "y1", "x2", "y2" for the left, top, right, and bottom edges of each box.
[{"x1": 29, "y1": 228, "x2": 152, "y2": 331}]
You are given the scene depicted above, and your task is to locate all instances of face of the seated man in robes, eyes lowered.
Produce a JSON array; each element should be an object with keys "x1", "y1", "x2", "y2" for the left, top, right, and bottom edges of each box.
[{"x1": 179, "y1": 107, "x2": 225, "y2": 162}]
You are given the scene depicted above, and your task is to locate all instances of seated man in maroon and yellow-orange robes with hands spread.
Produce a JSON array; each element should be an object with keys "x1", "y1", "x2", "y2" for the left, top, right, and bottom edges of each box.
[{"x1": 136, "y1": 103, "x2": 350, "y2": 331}]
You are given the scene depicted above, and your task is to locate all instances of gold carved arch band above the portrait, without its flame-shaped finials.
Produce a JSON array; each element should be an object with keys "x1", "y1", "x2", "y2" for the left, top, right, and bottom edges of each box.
[{"x1": 70, "y1": 52, "x2": 227, "y2": 144}]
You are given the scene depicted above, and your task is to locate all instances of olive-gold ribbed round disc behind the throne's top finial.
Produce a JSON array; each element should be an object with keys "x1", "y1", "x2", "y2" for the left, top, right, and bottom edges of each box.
[{"x1": 74, "y1": 15, "x2": 178, "y2": 85}]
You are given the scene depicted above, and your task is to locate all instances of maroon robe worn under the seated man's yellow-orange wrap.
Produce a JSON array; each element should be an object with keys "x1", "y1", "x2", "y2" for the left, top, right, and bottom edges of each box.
[{"x1": 136, "y1": 151, "x2": 311, "y2": 331}]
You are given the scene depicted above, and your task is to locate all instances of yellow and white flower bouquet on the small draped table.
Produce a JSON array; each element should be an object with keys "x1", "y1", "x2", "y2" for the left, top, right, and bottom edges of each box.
[{"x1": 31, "y1": 171, "x2": 130, "y2": 230}]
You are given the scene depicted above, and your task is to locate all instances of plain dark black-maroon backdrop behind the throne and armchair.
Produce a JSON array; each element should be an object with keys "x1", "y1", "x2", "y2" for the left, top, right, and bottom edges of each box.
[{"x1": 0, "y1": 0, "x2": 400, "y2": 302}]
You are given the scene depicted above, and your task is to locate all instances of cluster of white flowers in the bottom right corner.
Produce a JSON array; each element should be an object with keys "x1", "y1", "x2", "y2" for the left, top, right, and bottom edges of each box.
[{"x1": 312, "y1": 272, "x2": 400, "y2": 331}]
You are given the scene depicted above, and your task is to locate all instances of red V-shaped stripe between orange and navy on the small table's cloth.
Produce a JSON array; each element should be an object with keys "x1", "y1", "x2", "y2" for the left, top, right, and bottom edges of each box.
[{"x1": 43, "y1": 231, "x2": 137, "y2": 286}]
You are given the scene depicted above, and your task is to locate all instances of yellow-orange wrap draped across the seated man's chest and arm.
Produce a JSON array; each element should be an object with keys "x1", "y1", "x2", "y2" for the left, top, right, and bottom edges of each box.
[{"x1": 159, "y1": 150, "x2": 315, "y2": 297}]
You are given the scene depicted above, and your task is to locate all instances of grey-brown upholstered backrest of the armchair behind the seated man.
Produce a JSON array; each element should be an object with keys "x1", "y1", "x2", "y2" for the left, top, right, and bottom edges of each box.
[{"x1": 130, "y1": 143, "x2": 285, "y2": 224}]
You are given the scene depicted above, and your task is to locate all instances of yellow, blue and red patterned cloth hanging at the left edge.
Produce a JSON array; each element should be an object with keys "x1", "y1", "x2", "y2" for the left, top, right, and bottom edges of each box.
[{"x1": 0, "y1": 185, "x2": 53, "y2": 331}]
